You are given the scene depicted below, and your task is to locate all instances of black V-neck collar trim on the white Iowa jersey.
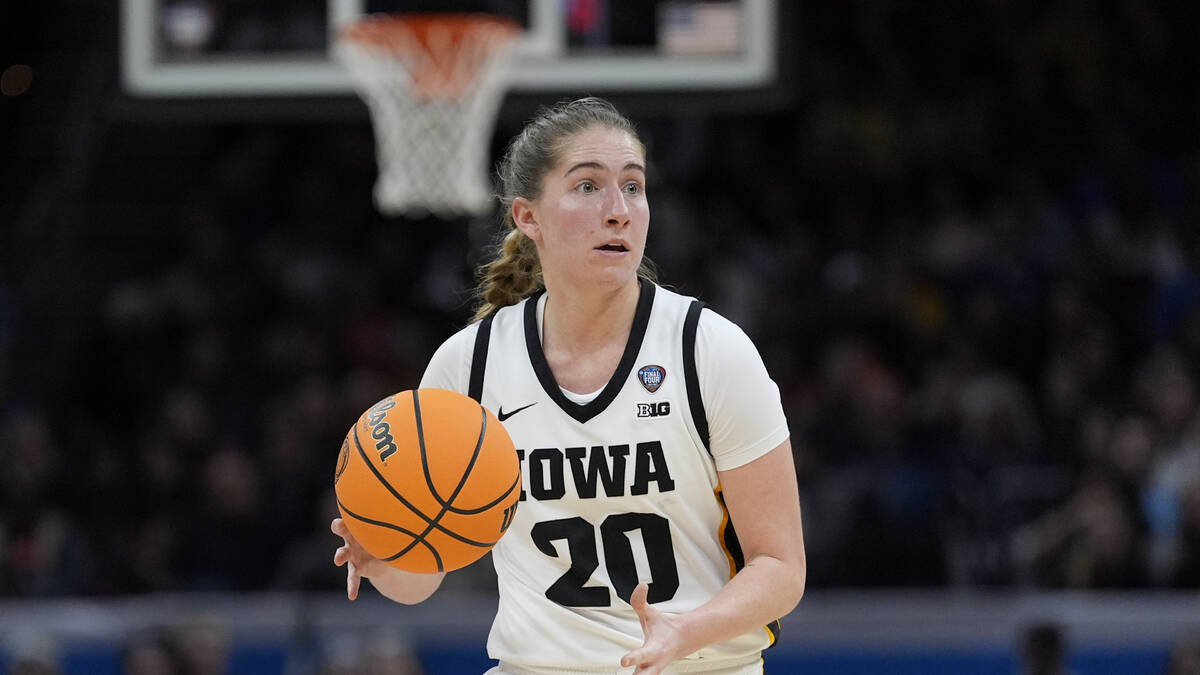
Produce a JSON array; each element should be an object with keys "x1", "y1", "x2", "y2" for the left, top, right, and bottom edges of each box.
[{"x1": 524, "y1": 281, "x2": 656, "y2": 424}]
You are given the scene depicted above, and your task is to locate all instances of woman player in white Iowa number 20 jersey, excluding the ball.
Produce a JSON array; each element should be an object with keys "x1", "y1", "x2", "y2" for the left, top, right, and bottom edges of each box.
[{"x1": 332, "y1": 98, "x2": 805, "y2": 675}]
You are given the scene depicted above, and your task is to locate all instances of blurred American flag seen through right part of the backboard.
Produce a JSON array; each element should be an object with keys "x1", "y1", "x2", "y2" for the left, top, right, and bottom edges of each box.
[{"x1": 659, "y1": 2, "x2": 742, "y2": 55}]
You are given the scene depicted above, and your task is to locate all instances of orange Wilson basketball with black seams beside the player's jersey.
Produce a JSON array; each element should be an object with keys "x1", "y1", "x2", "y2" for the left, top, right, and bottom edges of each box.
[{"x1": 334, "y1": 389, "x2": 521, "y2": 573}]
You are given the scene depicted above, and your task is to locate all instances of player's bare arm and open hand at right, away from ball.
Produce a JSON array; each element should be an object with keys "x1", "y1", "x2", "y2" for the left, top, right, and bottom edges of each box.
[{"x1": 620, "y1": 432, "x2": 806, "y2": 675}]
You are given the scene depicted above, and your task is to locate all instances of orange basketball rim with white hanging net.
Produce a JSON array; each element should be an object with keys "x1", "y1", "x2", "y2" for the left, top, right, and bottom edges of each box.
[{"x1": 334, "y1": 14, "x2": 521, "y2": 216}]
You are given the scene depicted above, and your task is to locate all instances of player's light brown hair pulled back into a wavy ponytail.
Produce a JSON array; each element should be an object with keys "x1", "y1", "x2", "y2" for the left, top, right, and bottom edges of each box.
[{"x1": 472, "y1": 96, "x2": 655, "y2": 321}]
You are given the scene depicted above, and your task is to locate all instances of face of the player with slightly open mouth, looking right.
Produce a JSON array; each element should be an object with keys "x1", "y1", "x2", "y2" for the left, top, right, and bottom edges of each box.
[{"x1": 514, "y1": 126, "x2": 650, "y2": 287}]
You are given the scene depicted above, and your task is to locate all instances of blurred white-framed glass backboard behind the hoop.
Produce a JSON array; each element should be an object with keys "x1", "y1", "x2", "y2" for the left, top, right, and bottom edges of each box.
[{"x1": 121, "y1": 0, "x2": 779, "y2": 98}]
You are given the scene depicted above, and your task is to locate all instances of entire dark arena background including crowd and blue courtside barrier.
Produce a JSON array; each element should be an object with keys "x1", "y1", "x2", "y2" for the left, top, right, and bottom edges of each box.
[{"x1": 0, "y1": 0, "x2": 1200, "y2": 675}]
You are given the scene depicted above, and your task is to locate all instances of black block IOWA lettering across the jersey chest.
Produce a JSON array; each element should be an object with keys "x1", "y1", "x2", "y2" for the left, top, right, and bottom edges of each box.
[{"x1": 517, "y1": 441, "x2": 674, "y2": 501}]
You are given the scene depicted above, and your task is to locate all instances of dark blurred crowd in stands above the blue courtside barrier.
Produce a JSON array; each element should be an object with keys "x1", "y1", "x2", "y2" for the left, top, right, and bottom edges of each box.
[{"x1": 0, "y1": 0, "x2": 1200, "y2": 605}]
